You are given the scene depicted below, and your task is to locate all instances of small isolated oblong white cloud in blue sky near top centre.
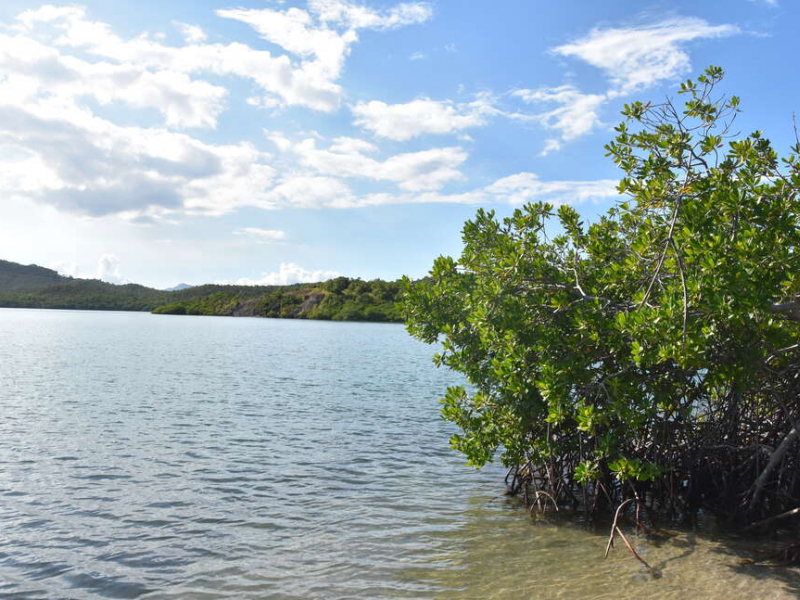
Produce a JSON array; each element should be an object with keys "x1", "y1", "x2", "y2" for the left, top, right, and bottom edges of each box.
[{"x1": 350, "y1": 95, "x2": 498, "y2": 141}]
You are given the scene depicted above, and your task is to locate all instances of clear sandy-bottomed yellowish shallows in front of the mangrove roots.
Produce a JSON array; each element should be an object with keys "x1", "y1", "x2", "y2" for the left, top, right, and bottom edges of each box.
[{"x1": 402, "y1": 496, "x2": 800, "y2": 600}]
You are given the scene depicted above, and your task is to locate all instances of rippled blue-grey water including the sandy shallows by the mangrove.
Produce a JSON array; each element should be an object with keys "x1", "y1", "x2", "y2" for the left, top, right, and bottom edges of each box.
[{"x1": 0, "y1": 310, "x2": 800, "y2": 600}]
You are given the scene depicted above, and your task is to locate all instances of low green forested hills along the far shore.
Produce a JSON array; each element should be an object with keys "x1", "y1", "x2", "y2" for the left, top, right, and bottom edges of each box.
[{"x1": 0, "y1": 260, "x2": 402, "y2": 321}]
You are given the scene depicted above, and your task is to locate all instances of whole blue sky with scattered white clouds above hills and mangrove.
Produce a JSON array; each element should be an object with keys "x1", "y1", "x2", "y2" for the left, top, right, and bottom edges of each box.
[{"x1": 0, "y1": 0, "x2": 800, "y2": 287}]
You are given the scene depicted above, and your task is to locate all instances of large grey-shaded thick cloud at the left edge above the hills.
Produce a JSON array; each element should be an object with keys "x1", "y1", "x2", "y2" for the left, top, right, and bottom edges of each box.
[{"x1": 0, "y1": 97, "x2": 275, "y2": 218}]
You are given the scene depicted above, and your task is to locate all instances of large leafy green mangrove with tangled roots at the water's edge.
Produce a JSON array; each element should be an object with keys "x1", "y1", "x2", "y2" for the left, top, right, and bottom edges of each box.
[{"x1": 404, "y1": 67, "x2": 800, "y2": 552}]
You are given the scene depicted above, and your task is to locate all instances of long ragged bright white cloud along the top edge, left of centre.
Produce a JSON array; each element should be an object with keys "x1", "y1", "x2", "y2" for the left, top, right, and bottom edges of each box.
[{"x1": 17, "y1": 1, "x2": 432, "y2": 116}]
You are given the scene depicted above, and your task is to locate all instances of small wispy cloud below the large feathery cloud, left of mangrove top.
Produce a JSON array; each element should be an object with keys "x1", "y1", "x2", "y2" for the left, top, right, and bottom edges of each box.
[{"x1": 512, "y1": 85, "x2": 606, "y2": 141}]
